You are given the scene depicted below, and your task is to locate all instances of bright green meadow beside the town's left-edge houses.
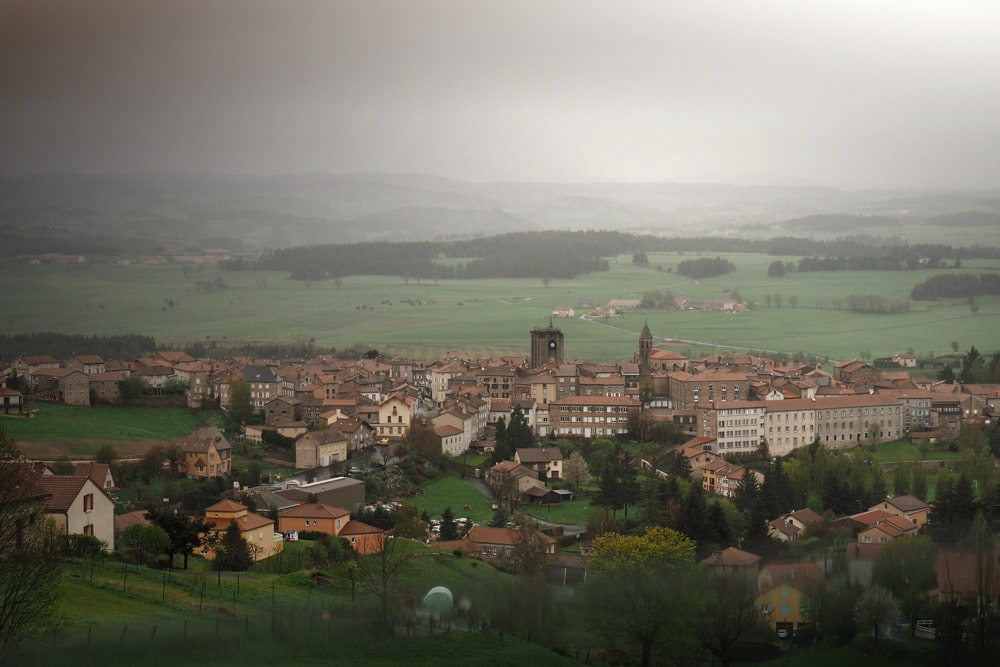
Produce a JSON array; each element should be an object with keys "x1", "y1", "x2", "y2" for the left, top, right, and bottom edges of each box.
[{"x1": 0, "y1": 402, "x2": 198, "y2": 444}]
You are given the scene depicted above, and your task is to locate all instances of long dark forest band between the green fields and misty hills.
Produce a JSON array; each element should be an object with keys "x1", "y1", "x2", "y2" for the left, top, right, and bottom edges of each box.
[{"x1": 236, "y1": 230, "x2": 1000, "y2": 280}]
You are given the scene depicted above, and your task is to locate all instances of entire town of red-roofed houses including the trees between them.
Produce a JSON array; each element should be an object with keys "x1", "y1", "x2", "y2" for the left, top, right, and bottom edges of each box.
[{"x1": 0, "y1": 321, "x2": 1000, "y2": 660}]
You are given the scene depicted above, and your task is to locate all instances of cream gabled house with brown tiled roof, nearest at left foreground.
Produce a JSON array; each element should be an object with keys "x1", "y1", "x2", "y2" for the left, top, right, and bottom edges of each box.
[{"x1": 38, "y1": 475, "x2": 115, "y2": 551}]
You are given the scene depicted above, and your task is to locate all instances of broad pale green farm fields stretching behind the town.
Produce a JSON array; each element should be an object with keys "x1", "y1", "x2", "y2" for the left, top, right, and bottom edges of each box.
[{"x1": 0, "y1": 254, "x2": 1000, "y2": 361}]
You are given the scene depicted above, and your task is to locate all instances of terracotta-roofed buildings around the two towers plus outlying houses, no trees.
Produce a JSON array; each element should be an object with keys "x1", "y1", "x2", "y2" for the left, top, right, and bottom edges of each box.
[{"x1": 0, "y1": 322, "x2": 1000, "y2": 633}]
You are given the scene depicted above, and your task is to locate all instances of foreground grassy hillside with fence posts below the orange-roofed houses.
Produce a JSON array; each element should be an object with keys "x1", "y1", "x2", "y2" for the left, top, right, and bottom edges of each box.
[{"x1": 17, "y1": 550, "x2": 573, "y2": 667}]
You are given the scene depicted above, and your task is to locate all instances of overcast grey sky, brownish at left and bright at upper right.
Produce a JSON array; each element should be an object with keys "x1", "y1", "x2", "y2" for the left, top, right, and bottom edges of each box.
[{"x1": 0, "y1": 0, "x2": 1000, "y2": 187}]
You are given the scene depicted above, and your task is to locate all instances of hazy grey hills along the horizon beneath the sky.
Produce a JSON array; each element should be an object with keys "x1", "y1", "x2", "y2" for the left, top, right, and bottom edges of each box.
[{"x1": 0, "y1": 174, "x2": 1000, "y2": 256}]
